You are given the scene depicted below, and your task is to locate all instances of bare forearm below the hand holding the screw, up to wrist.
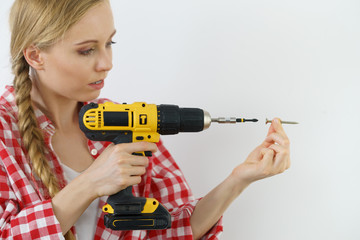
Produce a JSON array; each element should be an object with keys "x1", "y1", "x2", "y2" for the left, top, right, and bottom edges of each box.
[{"x1": 190, "y1": 175, "x2": 249, "y2": 239}]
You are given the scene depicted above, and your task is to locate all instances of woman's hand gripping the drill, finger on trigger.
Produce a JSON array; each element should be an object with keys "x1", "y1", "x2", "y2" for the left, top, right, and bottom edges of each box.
[{"x1": 84, "y1": 142, "x2": 157, "y2": 198}]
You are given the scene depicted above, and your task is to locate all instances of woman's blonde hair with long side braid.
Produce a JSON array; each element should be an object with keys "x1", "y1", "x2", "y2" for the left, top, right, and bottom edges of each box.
[{"x1": 10, "y1": 0, "x2": 105, "y2": 239}]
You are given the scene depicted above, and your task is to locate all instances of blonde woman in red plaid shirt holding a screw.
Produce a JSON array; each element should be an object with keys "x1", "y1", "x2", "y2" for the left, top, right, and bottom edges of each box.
[{"x1": 0, "y1": 0, "x2": 290, "y2": 239}]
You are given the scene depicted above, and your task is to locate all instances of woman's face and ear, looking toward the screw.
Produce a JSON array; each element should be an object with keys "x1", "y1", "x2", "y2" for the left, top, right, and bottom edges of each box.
[{"x1": 36, "y1": 1, "x2": 115, "y2": 102}]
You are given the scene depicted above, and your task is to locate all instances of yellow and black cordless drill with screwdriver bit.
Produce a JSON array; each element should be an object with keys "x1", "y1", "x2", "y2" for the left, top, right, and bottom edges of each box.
[{"x1": 79, "y1": 102, "x2": 257, "y2": 230}]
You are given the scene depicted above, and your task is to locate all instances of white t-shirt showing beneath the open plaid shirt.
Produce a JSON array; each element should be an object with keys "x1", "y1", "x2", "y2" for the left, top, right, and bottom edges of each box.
[{"x1": 61, "y1": 163, "x2": 99, "y2": 240}]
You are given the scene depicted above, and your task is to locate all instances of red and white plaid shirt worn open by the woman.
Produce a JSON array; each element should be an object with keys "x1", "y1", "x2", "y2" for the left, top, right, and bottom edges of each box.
[{"x1": 0, "y1": 86, "x2": 223, "y2": 240}]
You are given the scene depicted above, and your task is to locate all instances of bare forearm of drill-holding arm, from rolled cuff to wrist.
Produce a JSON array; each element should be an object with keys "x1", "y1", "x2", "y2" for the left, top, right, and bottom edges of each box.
[{"x1": 52, "y1": 174, "x2": 95, "y2": 234}]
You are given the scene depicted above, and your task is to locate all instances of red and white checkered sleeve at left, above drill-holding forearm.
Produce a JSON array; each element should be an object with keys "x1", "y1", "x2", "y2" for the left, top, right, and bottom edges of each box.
[{"x1": 0, "y1": 111, "x2": 63, "y2": 239}]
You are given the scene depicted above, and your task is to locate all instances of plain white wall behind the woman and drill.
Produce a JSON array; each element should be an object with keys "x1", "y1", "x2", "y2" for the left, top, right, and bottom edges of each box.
[{"x1": 0, "y1": 0, "x2": 360, "y2": 240}]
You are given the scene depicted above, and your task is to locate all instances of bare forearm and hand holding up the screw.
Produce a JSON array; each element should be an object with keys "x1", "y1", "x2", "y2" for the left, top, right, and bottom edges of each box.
[{"x1": 190, "y1": 119, "x2": 290, "y2": 239}]
